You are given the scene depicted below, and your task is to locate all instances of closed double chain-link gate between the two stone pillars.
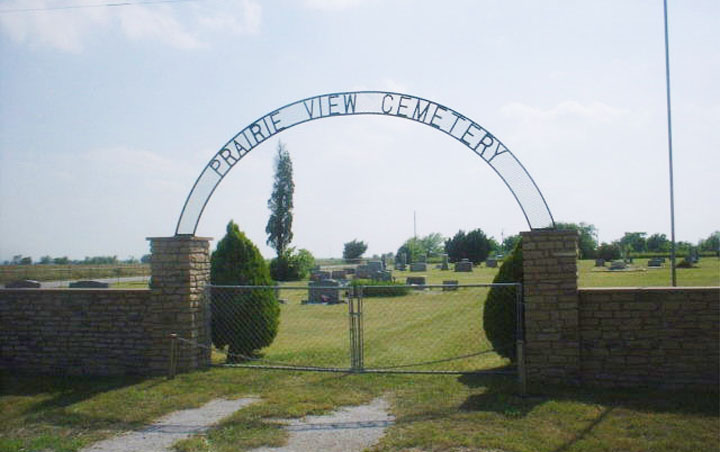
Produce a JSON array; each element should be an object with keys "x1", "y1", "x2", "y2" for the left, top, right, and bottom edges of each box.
[{"x1": 179, "y1": 281, "x2": 521, "y2": 373}]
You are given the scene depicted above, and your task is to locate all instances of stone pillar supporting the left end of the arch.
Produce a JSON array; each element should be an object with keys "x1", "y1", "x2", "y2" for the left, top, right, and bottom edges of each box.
[{"x1": 145, "y1": 236, "x2": 211, "y2": 374}]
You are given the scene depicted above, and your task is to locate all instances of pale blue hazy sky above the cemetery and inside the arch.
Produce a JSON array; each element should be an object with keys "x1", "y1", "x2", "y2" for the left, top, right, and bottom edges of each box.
[{"x1": 0, "y1": 0, "x2": 720, "y2": 261}]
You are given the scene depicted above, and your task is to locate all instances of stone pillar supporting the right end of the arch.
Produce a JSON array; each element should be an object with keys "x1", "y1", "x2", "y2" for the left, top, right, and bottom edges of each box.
[{"x1": 521, "y1": 230, "x2": 580, "y2": 383}]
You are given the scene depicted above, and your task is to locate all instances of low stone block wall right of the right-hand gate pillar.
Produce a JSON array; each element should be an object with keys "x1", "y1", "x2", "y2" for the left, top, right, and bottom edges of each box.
[{"x1": 579, "y1": 287, "x2": 720, "y2": 388}]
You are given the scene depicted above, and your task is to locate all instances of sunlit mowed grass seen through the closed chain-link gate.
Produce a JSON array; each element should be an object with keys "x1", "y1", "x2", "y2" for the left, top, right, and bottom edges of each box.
[{"x1": 253, "y1": 287, "x2": 506, "y2": 371}]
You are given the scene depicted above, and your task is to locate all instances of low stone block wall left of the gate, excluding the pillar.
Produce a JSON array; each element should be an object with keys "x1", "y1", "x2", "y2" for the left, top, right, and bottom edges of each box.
[{"x1": 0, "y1": 289, "x2": 153, "y2": 375}]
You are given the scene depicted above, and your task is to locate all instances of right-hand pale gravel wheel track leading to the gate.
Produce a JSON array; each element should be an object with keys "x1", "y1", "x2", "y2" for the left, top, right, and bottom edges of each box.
[{"x1": 250, "y1": 399, "x2": 395, "y2": 452}]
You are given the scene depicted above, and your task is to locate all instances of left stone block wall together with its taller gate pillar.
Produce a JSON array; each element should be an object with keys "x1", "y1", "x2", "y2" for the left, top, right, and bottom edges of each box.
[{"x1": 0, "y1": 236, "x2": 211, "y2": 375}]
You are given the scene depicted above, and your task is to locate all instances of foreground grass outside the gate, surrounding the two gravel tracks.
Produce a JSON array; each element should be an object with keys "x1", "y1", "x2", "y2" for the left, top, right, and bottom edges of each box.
[{"x1": 0, "y1": 368, "x2": 720, "y2": 452}]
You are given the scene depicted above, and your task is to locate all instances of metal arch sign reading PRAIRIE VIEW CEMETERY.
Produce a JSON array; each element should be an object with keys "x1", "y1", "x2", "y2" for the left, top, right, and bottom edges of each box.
[{"x1": 175, "y1": 91, "x2": 555, "y2": 235}]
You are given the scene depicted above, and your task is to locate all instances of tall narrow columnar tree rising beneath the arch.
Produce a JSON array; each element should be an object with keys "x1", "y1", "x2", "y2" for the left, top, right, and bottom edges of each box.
[{"x1": 265, "y1": 141, "x2": 295, "y2": 257}]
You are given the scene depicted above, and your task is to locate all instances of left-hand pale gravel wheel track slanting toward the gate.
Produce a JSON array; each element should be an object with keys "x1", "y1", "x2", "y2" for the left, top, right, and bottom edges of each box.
[{"x1": 80, "y1": 398, "x2": 259, "y2": 452}]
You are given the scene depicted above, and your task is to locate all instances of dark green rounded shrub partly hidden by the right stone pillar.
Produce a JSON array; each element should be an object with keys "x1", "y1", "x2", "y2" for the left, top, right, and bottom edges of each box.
[{"x1": 483, "y1": 240, "x2": 523, "y2": 361}]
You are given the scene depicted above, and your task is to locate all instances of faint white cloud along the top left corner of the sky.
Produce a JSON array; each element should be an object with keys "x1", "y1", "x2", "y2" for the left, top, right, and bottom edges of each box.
[{"x1": 0, "y1": 0, "x2": 262, "y2": 53}]
